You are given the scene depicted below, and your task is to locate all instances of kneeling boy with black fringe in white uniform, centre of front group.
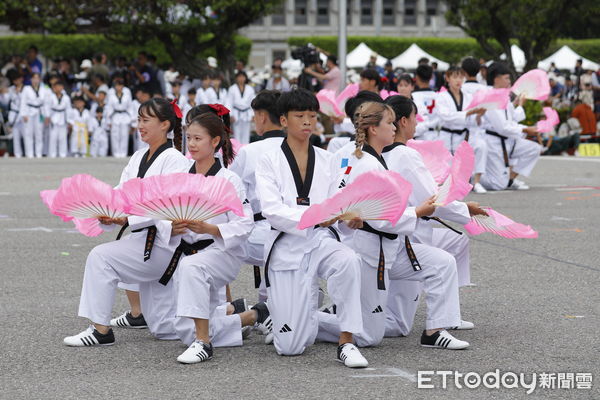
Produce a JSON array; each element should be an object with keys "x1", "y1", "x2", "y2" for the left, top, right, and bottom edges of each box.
[{"x1": 256, "y1": 89, "x2": 368, "y2": 367}]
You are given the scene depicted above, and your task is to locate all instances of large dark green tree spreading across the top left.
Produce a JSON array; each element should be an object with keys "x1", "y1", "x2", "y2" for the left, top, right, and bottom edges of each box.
[{"x1": 0, "y1": 0, "x2": 282, "y2": 76}]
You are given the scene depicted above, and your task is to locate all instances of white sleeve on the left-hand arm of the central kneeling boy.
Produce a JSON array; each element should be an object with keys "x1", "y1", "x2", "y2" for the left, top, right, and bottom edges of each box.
[{"x1": 256, "y1": 156, "x2": 309, "y2": 237}]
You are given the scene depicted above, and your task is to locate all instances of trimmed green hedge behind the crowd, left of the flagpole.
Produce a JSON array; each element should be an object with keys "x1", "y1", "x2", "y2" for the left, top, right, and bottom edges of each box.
[{"x1": 0, "y1": 34, "x2": 252, "y2": 65}]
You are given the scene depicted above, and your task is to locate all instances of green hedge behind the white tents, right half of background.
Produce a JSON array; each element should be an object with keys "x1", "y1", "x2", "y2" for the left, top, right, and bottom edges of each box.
[{"x1": 288, "y1": 36, "x2": 600, "y2": 63}]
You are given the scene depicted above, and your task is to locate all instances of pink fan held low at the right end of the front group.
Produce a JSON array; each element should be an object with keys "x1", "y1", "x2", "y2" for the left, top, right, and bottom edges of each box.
[{"x1": 465, "y1": 207, "x2": 538, "y2": 239}]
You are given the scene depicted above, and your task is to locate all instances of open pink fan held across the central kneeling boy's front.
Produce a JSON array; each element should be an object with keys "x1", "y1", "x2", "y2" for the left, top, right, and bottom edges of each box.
[{"x1": 298, "y1": 171, "x2": 412, "y2": 229}]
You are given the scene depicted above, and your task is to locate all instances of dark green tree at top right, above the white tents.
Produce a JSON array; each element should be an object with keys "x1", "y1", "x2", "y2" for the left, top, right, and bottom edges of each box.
[{"x1": 446, "y1": 0, "x2": 584, "y2": 71}]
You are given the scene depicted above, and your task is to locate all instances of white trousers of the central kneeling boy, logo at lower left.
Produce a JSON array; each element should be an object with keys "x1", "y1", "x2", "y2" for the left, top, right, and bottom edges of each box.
[{"x1": 267, "y1": 237, "x2": 363, "y2": 355}]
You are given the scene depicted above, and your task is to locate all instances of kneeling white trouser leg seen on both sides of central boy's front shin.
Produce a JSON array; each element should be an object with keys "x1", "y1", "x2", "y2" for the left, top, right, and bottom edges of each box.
[{"x1": 317, "y1": 261, "x2": 390, "y2": 347}]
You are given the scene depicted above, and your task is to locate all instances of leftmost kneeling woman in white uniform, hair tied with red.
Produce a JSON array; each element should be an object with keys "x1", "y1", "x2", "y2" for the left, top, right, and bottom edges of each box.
[{"x1": 64, "y1": 99, "x2": 189, "y2": 347}]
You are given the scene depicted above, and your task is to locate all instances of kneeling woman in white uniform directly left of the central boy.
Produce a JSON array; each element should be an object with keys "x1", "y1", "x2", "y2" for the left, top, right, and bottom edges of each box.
[{"x1": 171, "y1": 113, "x2": 269, "y2": 364}]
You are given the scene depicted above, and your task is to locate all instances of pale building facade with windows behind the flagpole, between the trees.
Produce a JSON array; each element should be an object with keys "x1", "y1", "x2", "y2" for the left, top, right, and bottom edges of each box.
[{"x1": 240, "y1": 0, "x2": 464, "y2": 68}]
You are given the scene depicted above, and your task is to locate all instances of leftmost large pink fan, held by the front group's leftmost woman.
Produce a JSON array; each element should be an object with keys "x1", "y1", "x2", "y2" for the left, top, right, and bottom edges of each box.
[{"x1": 47, "y1": 174, "x2": 128, "y2": 221}]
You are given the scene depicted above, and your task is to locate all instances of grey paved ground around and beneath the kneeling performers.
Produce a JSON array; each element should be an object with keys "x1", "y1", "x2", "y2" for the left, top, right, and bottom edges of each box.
[{"x1": 0, "y1": 158, "x2": 600, "y2": 399}]
